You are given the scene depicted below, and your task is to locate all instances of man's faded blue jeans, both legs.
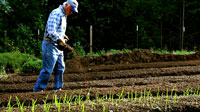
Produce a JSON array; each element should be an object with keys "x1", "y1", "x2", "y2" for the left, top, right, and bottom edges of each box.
[{"x1": 33, "y1": 40, "x2": 65, "y2": 91}]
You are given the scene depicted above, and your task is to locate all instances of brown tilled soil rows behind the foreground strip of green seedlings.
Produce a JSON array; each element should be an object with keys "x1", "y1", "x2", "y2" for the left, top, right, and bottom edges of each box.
[{"x1": 0, "y1": 50, "x2": 200, "y2": 112}]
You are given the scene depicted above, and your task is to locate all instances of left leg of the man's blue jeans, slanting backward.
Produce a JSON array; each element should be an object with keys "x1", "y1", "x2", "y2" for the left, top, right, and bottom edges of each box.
[{"x1": 33, "y1": 41, "x2": 59, "y2": 91}]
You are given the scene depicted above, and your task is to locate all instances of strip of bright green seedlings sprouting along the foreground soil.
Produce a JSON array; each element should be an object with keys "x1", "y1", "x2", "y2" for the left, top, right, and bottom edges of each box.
[{"x1": 2, "y1": 86, "x2": 200, "y2": 112}]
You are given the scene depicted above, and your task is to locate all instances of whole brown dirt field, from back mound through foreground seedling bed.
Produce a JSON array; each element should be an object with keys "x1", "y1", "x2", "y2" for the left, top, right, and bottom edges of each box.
[{"x1": 0, "y1": 50, "x2": 200, "y2": 112}]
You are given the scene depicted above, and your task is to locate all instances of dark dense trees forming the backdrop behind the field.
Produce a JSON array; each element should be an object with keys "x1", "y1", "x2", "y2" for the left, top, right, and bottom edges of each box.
[{"x1": 0, "y1": 0, "x2": 200, "y2": 56}]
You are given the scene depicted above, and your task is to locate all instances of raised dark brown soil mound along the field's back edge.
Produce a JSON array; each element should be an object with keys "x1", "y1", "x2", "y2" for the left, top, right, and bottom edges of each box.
[{"x1": 66, "y1": 50, "x2": 200, "y2": 73}]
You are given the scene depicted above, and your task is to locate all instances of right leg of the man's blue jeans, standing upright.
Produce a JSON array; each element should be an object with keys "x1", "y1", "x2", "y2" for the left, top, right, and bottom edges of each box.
[{"x1": 53, "y1": 55, "x2": 65, "y2": 89}]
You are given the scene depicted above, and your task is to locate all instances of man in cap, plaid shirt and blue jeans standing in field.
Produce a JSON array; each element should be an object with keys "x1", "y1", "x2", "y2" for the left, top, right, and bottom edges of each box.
[{"x1": 33, "y1": 0, "x2": 78, "y2": 92}]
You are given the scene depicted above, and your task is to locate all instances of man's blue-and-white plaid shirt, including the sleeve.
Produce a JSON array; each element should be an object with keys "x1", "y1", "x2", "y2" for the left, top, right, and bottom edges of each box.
[{"x1": 44, "y1": 5, "x2": 67, "y2": 41}]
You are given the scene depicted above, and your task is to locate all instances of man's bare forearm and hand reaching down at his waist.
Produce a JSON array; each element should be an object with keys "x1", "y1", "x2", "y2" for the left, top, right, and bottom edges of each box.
[{"x1": 57, "y1": 39, "x2": 76, "y2": 55}]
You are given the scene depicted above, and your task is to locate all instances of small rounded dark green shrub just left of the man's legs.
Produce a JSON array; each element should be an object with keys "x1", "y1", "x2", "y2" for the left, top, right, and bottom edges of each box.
[{"x1": 21, "y1": 59, "x2": 43, "y2": 73}]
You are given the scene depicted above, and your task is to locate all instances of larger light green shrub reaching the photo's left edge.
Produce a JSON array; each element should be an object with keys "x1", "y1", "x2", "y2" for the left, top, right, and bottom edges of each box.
[{"x1": 0, "y1": 51, "x2": 37, "y2": 74}]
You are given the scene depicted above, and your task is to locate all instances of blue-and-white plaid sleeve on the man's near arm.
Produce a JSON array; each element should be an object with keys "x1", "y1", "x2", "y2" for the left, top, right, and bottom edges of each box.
[{"x1": 46, "y1": 13, "x2": 61, "y2": 41}]
